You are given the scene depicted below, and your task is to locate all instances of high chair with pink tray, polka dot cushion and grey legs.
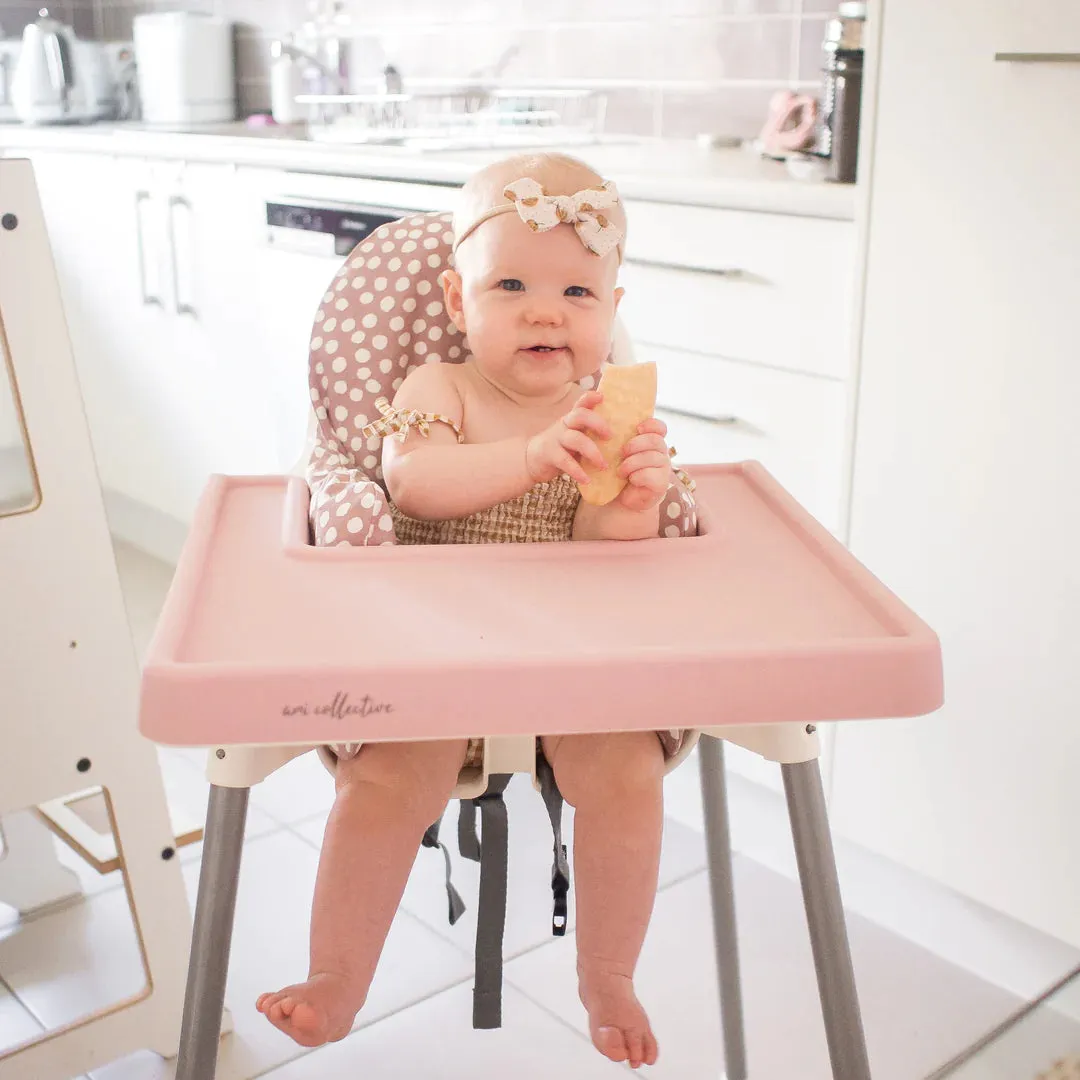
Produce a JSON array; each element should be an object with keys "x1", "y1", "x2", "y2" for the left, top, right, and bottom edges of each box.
[{"x1": 139, "y1": 206, "x2": 942, "y2": 1080}]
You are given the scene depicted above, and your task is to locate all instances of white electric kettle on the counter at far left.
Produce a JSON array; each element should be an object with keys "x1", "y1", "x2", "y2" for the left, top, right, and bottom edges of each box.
[{"x1": 11, "y1": 8, "x2": 117, "y2": 124}]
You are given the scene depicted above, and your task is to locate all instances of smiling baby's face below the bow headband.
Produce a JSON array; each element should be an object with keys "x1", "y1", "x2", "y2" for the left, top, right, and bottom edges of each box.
[{"x1": 444, "y1": 214, "x2": 622, "y2": 399}]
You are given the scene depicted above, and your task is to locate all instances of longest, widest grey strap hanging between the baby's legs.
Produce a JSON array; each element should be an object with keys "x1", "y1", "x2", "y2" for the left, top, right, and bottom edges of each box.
[{"x1": 470, "y1": 773, "x2": 512, "y2": 1030}]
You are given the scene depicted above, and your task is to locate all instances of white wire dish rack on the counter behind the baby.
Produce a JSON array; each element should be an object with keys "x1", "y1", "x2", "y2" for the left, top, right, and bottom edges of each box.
[{"x1": 296, "y1": 85, "x2": 607, "y2": 150}]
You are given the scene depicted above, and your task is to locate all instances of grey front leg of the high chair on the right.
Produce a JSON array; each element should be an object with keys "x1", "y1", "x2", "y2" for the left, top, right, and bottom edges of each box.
[{"x1": 782, "y1": 760, "x2": 870, "y2": 1080}]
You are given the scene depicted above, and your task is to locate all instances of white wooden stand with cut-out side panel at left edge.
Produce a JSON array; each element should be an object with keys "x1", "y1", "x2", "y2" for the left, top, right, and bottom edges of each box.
[{"x1": 0, "y1": 159, "x2": 191, "y2": 1080}]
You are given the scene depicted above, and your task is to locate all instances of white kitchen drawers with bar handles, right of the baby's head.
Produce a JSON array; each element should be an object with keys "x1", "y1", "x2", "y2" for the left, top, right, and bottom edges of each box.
[{"x1": 619, "y1": 201, "x2": 856, "y2": 791}]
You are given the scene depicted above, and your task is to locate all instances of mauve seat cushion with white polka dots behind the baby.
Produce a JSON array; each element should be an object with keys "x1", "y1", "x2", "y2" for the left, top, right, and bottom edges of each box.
[{"x1": 307, "y1": 214, "x2": 698, "y2": 546}]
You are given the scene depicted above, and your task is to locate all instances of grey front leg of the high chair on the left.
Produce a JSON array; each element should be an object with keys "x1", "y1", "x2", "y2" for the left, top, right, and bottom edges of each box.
[{"x1": 176, "y1": 784, "x2": 249, "y2": 1080}]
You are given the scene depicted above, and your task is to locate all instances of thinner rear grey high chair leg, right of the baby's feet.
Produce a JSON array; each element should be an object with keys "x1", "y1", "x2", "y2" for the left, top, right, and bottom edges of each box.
[{"x1": 698, "y1": 735, "x2": 746, "y2": 1080}]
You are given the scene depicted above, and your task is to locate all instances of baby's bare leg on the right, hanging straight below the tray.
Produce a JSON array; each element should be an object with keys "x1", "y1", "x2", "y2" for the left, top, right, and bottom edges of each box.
[{"x1": 543, "y1": 731, "x2": 664, "y2": 1068}]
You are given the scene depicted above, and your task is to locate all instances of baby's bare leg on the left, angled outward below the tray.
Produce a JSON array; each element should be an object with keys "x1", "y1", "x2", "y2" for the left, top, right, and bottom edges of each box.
[{"x1": 256, "y1": 740, "x2": 465, "y2": 1047}]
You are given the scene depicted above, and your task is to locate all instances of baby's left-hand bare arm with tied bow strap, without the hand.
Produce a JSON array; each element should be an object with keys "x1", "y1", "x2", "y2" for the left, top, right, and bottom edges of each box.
[{"x1": 382, "y1": 364, "x2": 535, "y2": 521}]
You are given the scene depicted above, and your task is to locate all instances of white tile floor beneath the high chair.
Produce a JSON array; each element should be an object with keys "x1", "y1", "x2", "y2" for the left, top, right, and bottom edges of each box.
[{"x1": 0, "y1": 546, "x2": 1071, "y2": 1080}]
